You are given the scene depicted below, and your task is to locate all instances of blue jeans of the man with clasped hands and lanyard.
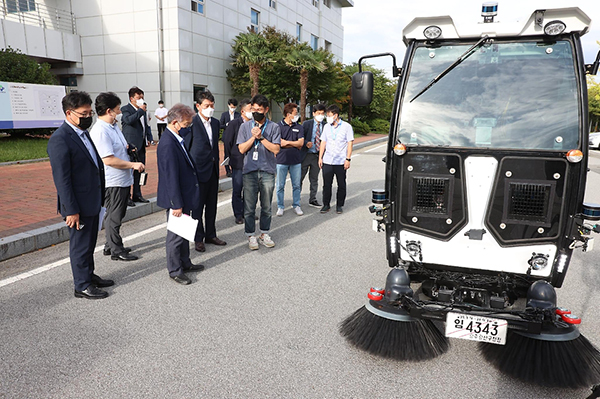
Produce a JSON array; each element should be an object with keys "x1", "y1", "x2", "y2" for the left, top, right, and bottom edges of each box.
[{"x1": 244, "y1": 171, "x2": 275, "y2": 237}]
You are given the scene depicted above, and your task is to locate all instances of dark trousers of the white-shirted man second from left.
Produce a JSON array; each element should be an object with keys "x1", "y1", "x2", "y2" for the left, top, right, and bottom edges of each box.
[{"x1": 104, "y1": 187, "x2": 129, "y2": 255}]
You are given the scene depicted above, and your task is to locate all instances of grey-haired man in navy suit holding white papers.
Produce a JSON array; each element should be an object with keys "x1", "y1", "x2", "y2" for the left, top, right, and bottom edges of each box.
[{"x1": 156, "y1": 103, "x2": 204, "y2": 285}]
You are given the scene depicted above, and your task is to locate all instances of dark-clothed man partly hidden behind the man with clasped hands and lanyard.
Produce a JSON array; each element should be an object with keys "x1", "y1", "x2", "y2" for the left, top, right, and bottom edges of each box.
[{"x1": 223, "y1": 99, "x2": 252, "y2": 224}]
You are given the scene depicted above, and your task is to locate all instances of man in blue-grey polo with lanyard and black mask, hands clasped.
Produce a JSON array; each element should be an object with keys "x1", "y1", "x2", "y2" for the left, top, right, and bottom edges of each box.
[{"x1": 237, "y1": 94, "x2": 281, "y2": 250}]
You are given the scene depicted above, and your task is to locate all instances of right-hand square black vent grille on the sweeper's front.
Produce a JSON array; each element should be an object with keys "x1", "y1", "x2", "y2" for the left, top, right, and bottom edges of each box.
[{"x1": 507, "y1": 183, "x2": 552, "y2": 223}]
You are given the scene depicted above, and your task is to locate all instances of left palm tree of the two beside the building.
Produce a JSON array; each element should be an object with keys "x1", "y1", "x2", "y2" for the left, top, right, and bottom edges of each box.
[{"x1": 233, "y1": 31, "x2": 273, "y2": 96}]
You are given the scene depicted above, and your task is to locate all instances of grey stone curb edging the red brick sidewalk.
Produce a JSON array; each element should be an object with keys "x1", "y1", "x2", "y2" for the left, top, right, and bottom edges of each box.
[{"x1": 0, "y1": 137, "x2": 388, "y2": 262}]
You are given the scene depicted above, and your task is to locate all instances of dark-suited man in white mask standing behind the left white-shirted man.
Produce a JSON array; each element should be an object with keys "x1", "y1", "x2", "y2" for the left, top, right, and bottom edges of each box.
[{"x1": 121, "y1": 86, "x2": 150, "y2": 206}]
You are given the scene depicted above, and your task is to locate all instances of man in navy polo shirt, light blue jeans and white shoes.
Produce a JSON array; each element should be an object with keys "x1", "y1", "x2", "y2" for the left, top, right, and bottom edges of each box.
[{"x1": 277, "y1": 103, "x2": 304, "y2": 216}]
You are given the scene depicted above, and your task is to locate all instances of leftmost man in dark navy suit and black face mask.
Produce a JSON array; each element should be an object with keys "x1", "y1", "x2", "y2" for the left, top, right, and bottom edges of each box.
[{"x1": 47, "y1": 91, "x2": 114, "y2": 299}]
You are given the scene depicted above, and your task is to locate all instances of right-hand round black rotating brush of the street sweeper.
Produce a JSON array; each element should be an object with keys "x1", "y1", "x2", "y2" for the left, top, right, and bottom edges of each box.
[{"x1": 479, "y1": 281, "x2": 600, "y2": 388}]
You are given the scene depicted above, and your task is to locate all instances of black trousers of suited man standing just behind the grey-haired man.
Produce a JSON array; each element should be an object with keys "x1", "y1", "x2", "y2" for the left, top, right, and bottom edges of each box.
[{"x1": 192, "y1": 169, "x2": 219, "y2": 242}]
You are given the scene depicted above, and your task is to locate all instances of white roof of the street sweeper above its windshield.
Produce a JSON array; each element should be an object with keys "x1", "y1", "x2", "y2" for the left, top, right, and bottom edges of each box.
[{"x1": 402, "y1": 7, "x2": 592, "y2": 45}]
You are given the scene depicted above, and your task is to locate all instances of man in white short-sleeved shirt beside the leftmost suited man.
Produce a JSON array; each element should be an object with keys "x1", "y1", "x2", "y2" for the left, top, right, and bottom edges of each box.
[{"x1": 90, "y1": 93, "x2": 144, "y2": 261}]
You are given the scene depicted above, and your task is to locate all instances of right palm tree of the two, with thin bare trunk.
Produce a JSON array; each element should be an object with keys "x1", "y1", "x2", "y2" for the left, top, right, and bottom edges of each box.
[{"x1": 285, "y1": 43, "x2": 327, "y2": 122}]
